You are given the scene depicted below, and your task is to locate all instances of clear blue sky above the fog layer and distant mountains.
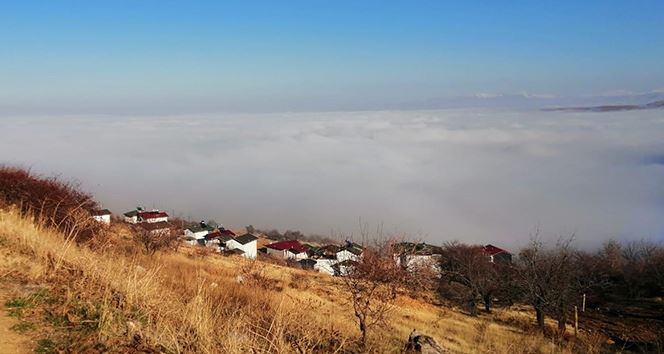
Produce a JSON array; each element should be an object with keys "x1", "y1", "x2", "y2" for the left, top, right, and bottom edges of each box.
[{"x1": 0, "y1": 0, "x2": 664, "y2": 113}]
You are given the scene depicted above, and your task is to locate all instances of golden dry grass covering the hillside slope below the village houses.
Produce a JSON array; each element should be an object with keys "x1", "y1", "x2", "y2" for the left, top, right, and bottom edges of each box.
[{"x1": 0, "y1": 209, "x2": 600, "y2": 353}]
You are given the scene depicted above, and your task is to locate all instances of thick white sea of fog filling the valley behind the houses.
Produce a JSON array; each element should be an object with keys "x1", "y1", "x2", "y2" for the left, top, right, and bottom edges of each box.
[{"x1": 0, "y1": 109, "x2": 664, "y2": 247}]
